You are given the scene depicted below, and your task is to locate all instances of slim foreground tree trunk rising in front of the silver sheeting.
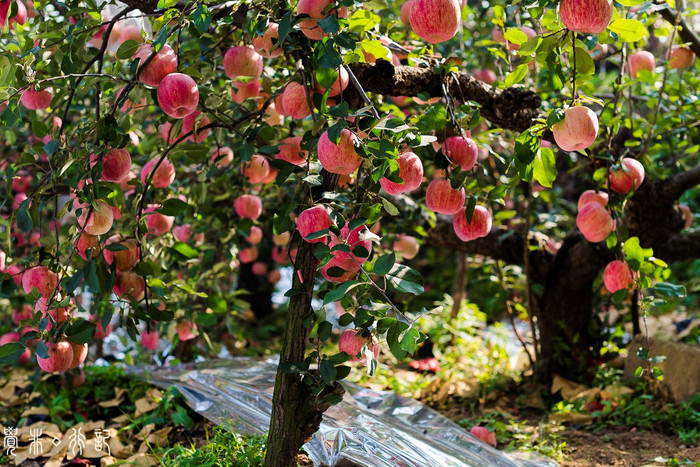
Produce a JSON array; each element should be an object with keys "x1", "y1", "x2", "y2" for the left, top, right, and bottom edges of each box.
[{"x1": 265, "y1": 172, "x2": 343, "y2": 467}]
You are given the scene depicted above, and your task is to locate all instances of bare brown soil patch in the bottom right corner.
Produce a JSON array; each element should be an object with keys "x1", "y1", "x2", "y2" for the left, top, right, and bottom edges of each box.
[{"x1": 560, "y1": 427, "x2": 700, "y2": 467}]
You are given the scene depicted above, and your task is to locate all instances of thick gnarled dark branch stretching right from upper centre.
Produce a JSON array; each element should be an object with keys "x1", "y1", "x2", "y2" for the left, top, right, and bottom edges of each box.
[{"x1": 345, "y1": 60, "x2": 542, "y2": 131}]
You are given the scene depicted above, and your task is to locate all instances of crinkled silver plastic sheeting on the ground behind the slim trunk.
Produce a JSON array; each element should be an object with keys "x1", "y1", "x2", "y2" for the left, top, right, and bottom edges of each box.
[{"x1": 127, "y1": 358, "x2": 557, "y2": 467}]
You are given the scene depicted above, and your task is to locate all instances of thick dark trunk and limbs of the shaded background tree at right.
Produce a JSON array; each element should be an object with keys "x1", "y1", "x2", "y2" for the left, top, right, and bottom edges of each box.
[{"x1": 428, "y1": 167, "x2": 700, "y2": 381}]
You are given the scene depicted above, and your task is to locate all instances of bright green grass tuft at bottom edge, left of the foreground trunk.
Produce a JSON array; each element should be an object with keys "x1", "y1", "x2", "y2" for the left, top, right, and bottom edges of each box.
[{"x1": 155, "y1": 425, "x2": 267, "y2": 467}]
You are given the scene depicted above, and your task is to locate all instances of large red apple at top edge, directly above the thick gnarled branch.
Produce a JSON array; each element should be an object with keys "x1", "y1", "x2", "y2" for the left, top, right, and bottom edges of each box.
[{"x1": 409, "y1": 0, "x2": 462, "y2": 44}]
